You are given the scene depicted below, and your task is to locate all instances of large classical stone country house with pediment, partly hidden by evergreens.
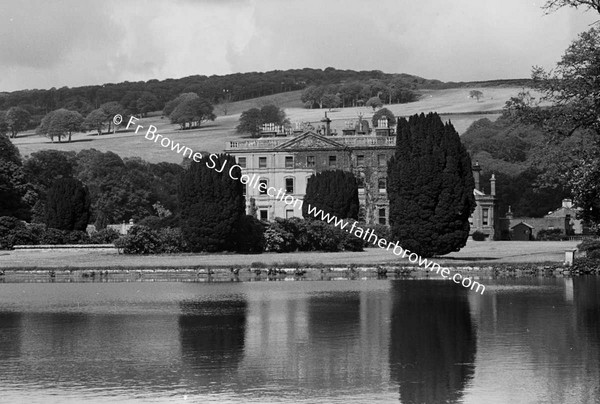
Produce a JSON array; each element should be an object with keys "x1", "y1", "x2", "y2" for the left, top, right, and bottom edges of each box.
[{"x1": 225, "y1": 120, "x2": 497, "y2": 240}]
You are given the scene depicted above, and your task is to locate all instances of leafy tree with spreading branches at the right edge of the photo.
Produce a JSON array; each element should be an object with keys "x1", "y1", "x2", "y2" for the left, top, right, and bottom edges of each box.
[{"x1": 504, "y1": 26, "x2": 600, "y2": 223}]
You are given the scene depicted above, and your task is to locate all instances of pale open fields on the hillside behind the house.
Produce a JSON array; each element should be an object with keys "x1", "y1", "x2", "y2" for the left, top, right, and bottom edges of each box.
[{"x1": 14, "y1": 87, "x2": 532, "y2": 163}]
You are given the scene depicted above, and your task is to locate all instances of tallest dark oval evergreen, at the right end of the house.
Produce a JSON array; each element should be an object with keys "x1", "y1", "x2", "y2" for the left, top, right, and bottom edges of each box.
[{"x1": 387, "y1": 113, "x2": 475, "y2": 257}]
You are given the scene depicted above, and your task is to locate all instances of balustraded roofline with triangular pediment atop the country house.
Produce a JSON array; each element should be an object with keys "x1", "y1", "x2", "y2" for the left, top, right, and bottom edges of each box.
[{"x1": 225, "y1": 131, "x2": 396, "y2": 152}]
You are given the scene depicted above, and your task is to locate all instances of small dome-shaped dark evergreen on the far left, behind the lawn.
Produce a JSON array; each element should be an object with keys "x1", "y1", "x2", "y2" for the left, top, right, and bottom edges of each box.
[{"x1": 46, "y1": 178, "x2": 91, "y2": 231}]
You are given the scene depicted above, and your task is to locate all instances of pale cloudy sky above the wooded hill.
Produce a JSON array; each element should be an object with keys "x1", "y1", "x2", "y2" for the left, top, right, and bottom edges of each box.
[{"x1": 0, "y1": 0, "x2": 600, "y2": 91}]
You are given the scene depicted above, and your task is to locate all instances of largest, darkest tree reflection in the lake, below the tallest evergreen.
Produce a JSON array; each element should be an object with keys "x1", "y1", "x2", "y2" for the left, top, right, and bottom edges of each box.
[{"x1": 390, "y1": 281, "x2": 477, "y2": 403}]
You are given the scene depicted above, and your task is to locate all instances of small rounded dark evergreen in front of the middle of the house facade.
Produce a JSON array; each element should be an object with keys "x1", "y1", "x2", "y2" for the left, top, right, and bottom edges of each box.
[{"x1": 302, "y1": 170, "x2": 359, "y2": 219}]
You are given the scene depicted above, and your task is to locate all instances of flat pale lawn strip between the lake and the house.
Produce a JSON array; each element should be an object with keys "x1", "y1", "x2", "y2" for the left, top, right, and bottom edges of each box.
[{"x1": 0, "y1": 240, "x2": 578, "y2": 268}]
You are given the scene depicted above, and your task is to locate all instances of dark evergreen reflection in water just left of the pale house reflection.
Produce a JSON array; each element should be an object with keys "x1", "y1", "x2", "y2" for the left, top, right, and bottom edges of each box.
[{"x1": 179, "y1": 300, "x2": 247, "y2": 376}]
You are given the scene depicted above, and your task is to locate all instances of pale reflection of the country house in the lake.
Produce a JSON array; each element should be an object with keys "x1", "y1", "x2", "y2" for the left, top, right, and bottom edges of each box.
[{"x1": 237, "y1": 282, "x2": 390, "y2": 394}]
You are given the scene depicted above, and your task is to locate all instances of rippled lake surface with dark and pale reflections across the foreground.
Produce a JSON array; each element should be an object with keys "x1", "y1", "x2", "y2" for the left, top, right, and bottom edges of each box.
[{"x1": 0, "y1": 278, "x2": 600, "y2": 403}]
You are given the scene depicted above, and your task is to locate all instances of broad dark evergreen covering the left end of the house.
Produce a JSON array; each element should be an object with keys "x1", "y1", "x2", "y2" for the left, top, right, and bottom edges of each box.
[{"x1": 178, "y1": 154, "x2": 245, "y2": 252}]
